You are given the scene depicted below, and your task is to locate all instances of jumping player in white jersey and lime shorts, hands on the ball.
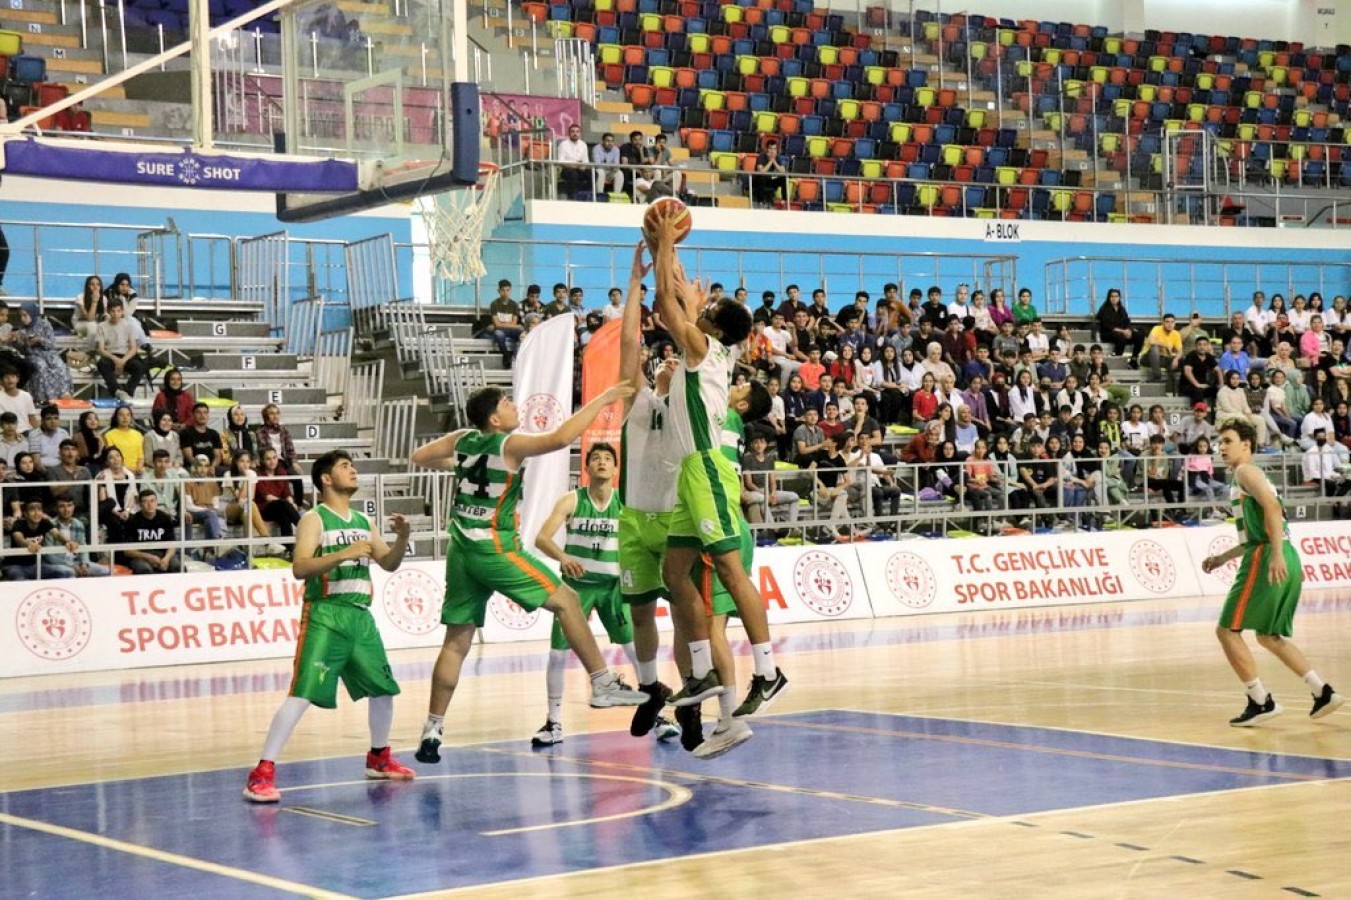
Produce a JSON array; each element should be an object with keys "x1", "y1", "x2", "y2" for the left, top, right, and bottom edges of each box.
[{"x1": 648, "y1": 206, "x2": 788, "y2": 741}]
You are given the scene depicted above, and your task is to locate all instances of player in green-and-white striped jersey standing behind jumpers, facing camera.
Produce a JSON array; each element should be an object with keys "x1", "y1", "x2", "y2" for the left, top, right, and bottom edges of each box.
[{"x1": 531, "y1": 442, "x2": 680, "y2": 747}]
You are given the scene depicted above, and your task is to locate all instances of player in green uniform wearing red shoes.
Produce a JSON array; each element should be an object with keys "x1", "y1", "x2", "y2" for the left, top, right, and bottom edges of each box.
[{"x1": 245, "y1": 450, "x2": 413, "y2": 803}]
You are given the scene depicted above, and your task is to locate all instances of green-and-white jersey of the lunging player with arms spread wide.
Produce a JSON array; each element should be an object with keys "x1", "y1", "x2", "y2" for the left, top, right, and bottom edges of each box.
[{"x1": 449, "y1": 431, "x2": 526, "y2": 553}]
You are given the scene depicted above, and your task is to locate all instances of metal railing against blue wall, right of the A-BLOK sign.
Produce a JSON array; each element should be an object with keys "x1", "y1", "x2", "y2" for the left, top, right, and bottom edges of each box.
[{"x1": 1046, "y1": 255, "x2": 1351, "y2": 322}]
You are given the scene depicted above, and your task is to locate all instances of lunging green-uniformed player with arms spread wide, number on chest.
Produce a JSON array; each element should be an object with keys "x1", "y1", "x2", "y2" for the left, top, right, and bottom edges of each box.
[{"x1": 412, "y1": 385, "x2": 647, "y2": 764}]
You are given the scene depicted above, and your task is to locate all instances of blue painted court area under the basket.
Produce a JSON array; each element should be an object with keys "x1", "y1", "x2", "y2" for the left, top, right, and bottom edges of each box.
[{"x1": 0, "y1": 711, "x2": 1351, "y2": 897}]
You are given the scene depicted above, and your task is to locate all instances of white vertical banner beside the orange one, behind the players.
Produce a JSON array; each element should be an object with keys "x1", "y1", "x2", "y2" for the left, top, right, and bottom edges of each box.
[{"x1": 512, "y1": 315, "x2": 577, "y2": 562}]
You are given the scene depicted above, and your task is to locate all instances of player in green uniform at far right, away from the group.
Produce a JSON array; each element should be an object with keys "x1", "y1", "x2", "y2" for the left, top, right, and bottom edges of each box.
[{"x1": 1201, "y1": 420, "x2": 1343, "y2": 727}]
